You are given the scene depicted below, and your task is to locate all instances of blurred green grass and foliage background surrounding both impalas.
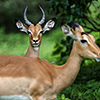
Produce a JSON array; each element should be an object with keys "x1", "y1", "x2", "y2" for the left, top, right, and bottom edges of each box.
[{"x1": 0, "y1": 0, "x2": 100, "y2": 100}]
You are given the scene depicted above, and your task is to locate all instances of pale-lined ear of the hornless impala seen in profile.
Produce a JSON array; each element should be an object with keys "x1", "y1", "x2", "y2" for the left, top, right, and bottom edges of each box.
[{"x1": 61, "y1": 24, "x2": 76, "y2": 39}]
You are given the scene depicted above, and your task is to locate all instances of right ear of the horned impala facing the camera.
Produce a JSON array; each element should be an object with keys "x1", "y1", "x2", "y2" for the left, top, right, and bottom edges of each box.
[{"x1": 43, "y1": 18, "x2": 56, "y2": 33}]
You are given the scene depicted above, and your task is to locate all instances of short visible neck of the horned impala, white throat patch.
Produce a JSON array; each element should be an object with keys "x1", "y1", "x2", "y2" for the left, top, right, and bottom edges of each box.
[{"x1": 24, "y1": 44, "x2": 39, "y2": 58}]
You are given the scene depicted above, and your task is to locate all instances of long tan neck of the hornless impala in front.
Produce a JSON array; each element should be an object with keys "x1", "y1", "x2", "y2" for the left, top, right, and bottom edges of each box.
[{"x1": 54, "y1": 43, "x2": 82, "y2": 94}]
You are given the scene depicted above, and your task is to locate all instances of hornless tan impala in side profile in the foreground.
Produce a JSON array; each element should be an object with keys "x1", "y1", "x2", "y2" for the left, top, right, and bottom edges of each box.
[{"x1": 0, "y1": 22, "x2": 100, "y2": 100}]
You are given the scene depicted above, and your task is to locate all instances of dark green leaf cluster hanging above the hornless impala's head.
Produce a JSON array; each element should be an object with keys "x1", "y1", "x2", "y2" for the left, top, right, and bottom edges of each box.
[{"x1": 46, "y1": 0, "x2": 96, "y2": 23}]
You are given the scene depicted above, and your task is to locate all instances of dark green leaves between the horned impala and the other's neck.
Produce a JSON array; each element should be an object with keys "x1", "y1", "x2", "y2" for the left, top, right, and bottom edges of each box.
[{"x1": 52, "y1": 37, "x2": 73, "y2": 65}]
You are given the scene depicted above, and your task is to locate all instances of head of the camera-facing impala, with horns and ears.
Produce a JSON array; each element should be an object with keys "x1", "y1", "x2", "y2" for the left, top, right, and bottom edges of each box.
[{"x1": 15, "y1": 6, "x2": 55, "y2": 48}]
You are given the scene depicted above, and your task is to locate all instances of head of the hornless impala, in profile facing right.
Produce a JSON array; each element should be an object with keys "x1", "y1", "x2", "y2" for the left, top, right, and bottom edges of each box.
[{"x1": 62, "y1": 22, "x2": 100, "y2": 61}]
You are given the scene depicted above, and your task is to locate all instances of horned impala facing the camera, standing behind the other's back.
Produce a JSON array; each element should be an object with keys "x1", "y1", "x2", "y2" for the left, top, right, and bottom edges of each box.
[{"x1": 15, "y1": 6, "x2": 55, "y2": 57}]
